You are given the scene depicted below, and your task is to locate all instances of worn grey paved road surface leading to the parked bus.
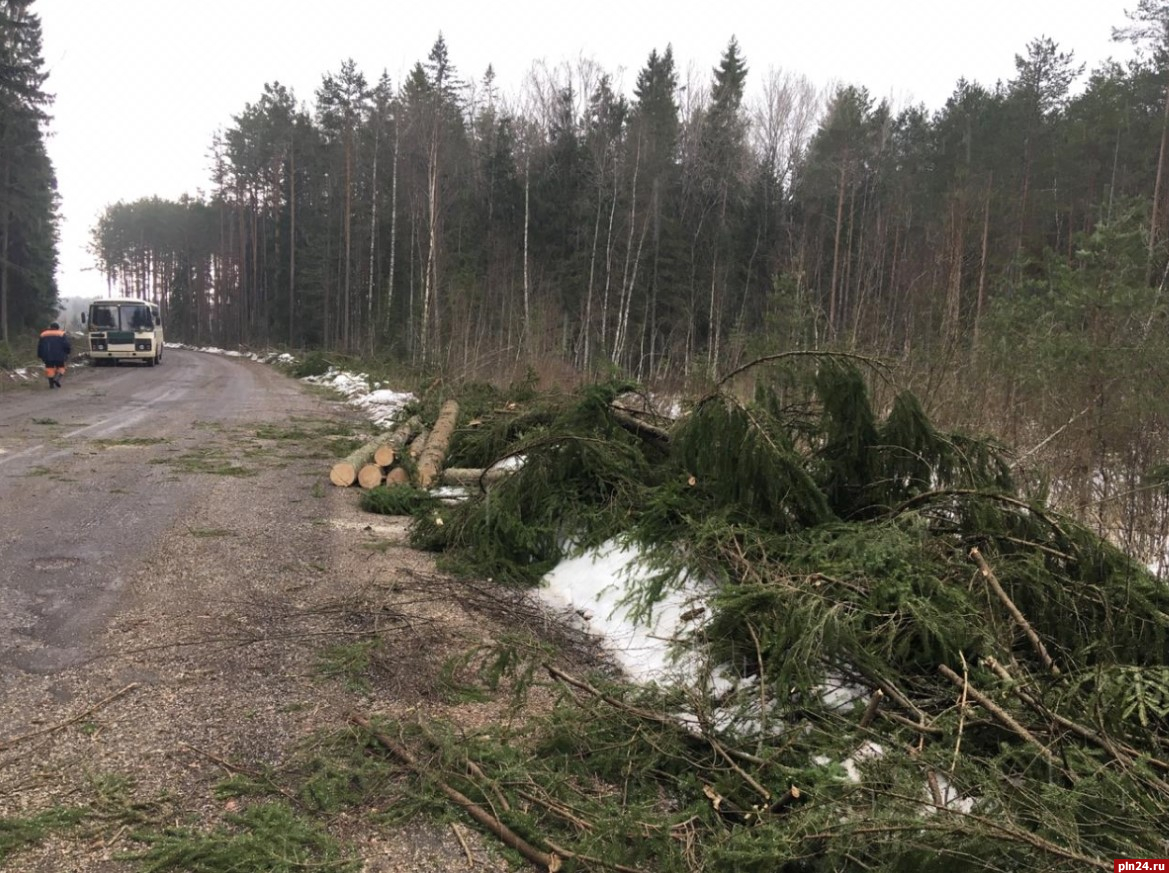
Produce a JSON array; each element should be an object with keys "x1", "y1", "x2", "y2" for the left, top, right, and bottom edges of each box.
[{"x1": 0, "y1": 349, "x2": 320, "y2": 675}]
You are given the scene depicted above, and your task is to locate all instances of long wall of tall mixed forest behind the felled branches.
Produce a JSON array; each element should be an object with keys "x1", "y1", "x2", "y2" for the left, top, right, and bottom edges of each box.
[{"x1": 95, "y1": 9, "x2": 1169, "y2": 377}]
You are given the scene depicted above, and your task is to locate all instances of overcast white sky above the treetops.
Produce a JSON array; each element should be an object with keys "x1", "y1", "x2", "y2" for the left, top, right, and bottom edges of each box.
[{"x1": 33, "y1": 0, "x2": 1136, "y2": 297}]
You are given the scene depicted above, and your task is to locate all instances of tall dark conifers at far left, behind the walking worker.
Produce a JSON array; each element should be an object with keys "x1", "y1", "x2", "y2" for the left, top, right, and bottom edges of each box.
[{"x1": 0, "y1": 0, "x2": 57, "y2": 346}]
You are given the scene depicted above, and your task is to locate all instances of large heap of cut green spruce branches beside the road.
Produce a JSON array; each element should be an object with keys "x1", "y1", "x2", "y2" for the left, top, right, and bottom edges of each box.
[{"x1": 360, "y1": 364, "x2": 1169, "y2": 873}]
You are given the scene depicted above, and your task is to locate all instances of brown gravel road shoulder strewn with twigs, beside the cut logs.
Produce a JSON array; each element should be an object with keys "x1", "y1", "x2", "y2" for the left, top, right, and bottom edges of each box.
[{"x1": 0, "y1": 369, "x2": 603, "y2": 873}]
